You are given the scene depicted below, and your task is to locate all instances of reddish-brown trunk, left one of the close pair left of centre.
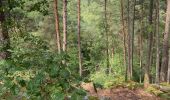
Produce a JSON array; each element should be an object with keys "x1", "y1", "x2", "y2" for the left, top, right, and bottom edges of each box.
[{"x1": 54, "y1": 0, "x2": 61, "y2": 54}]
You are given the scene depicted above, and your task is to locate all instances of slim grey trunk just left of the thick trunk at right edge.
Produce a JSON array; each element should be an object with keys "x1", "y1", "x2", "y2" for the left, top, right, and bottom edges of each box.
[{"x1": 155, "y1": 0, "x2": 160, "y2": 84}]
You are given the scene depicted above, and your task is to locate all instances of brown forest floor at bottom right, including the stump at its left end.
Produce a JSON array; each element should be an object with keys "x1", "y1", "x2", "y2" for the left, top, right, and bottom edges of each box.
[{"x1": 81, "y1": 83, "x2": 162, "y2": 100}]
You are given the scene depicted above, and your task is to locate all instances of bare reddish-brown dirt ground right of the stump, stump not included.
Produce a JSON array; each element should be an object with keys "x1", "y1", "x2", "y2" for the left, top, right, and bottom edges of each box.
[{"x1": 92, "y1": 87, "x2": 161, "y2": 100}]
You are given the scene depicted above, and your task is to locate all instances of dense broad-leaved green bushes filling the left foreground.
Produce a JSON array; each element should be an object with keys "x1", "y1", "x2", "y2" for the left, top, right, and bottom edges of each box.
[{"x1": 0, "y1": 34, "x2": 85, "y2": 100}]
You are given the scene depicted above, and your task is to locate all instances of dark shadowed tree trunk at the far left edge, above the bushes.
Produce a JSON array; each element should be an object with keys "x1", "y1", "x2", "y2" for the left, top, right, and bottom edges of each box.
[{"x1": 0, "y1": 0, "x2": 10, "y2": 60}]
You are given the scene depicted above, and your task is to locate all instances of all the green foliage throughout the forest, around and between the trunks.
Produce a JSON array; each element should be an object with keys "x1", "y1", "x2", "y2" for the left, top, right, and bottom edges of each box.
[{"x1": 0, "y1": 0, "x2": 167, "y2": 100}]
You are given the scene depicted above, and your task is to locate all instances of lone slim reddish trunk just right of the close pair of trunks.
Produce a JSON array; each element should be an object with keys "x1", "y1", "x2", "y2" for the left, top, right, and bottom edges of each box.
[{"x1": 77, "y1": 0, "x2": 82, "y2": 76}]
